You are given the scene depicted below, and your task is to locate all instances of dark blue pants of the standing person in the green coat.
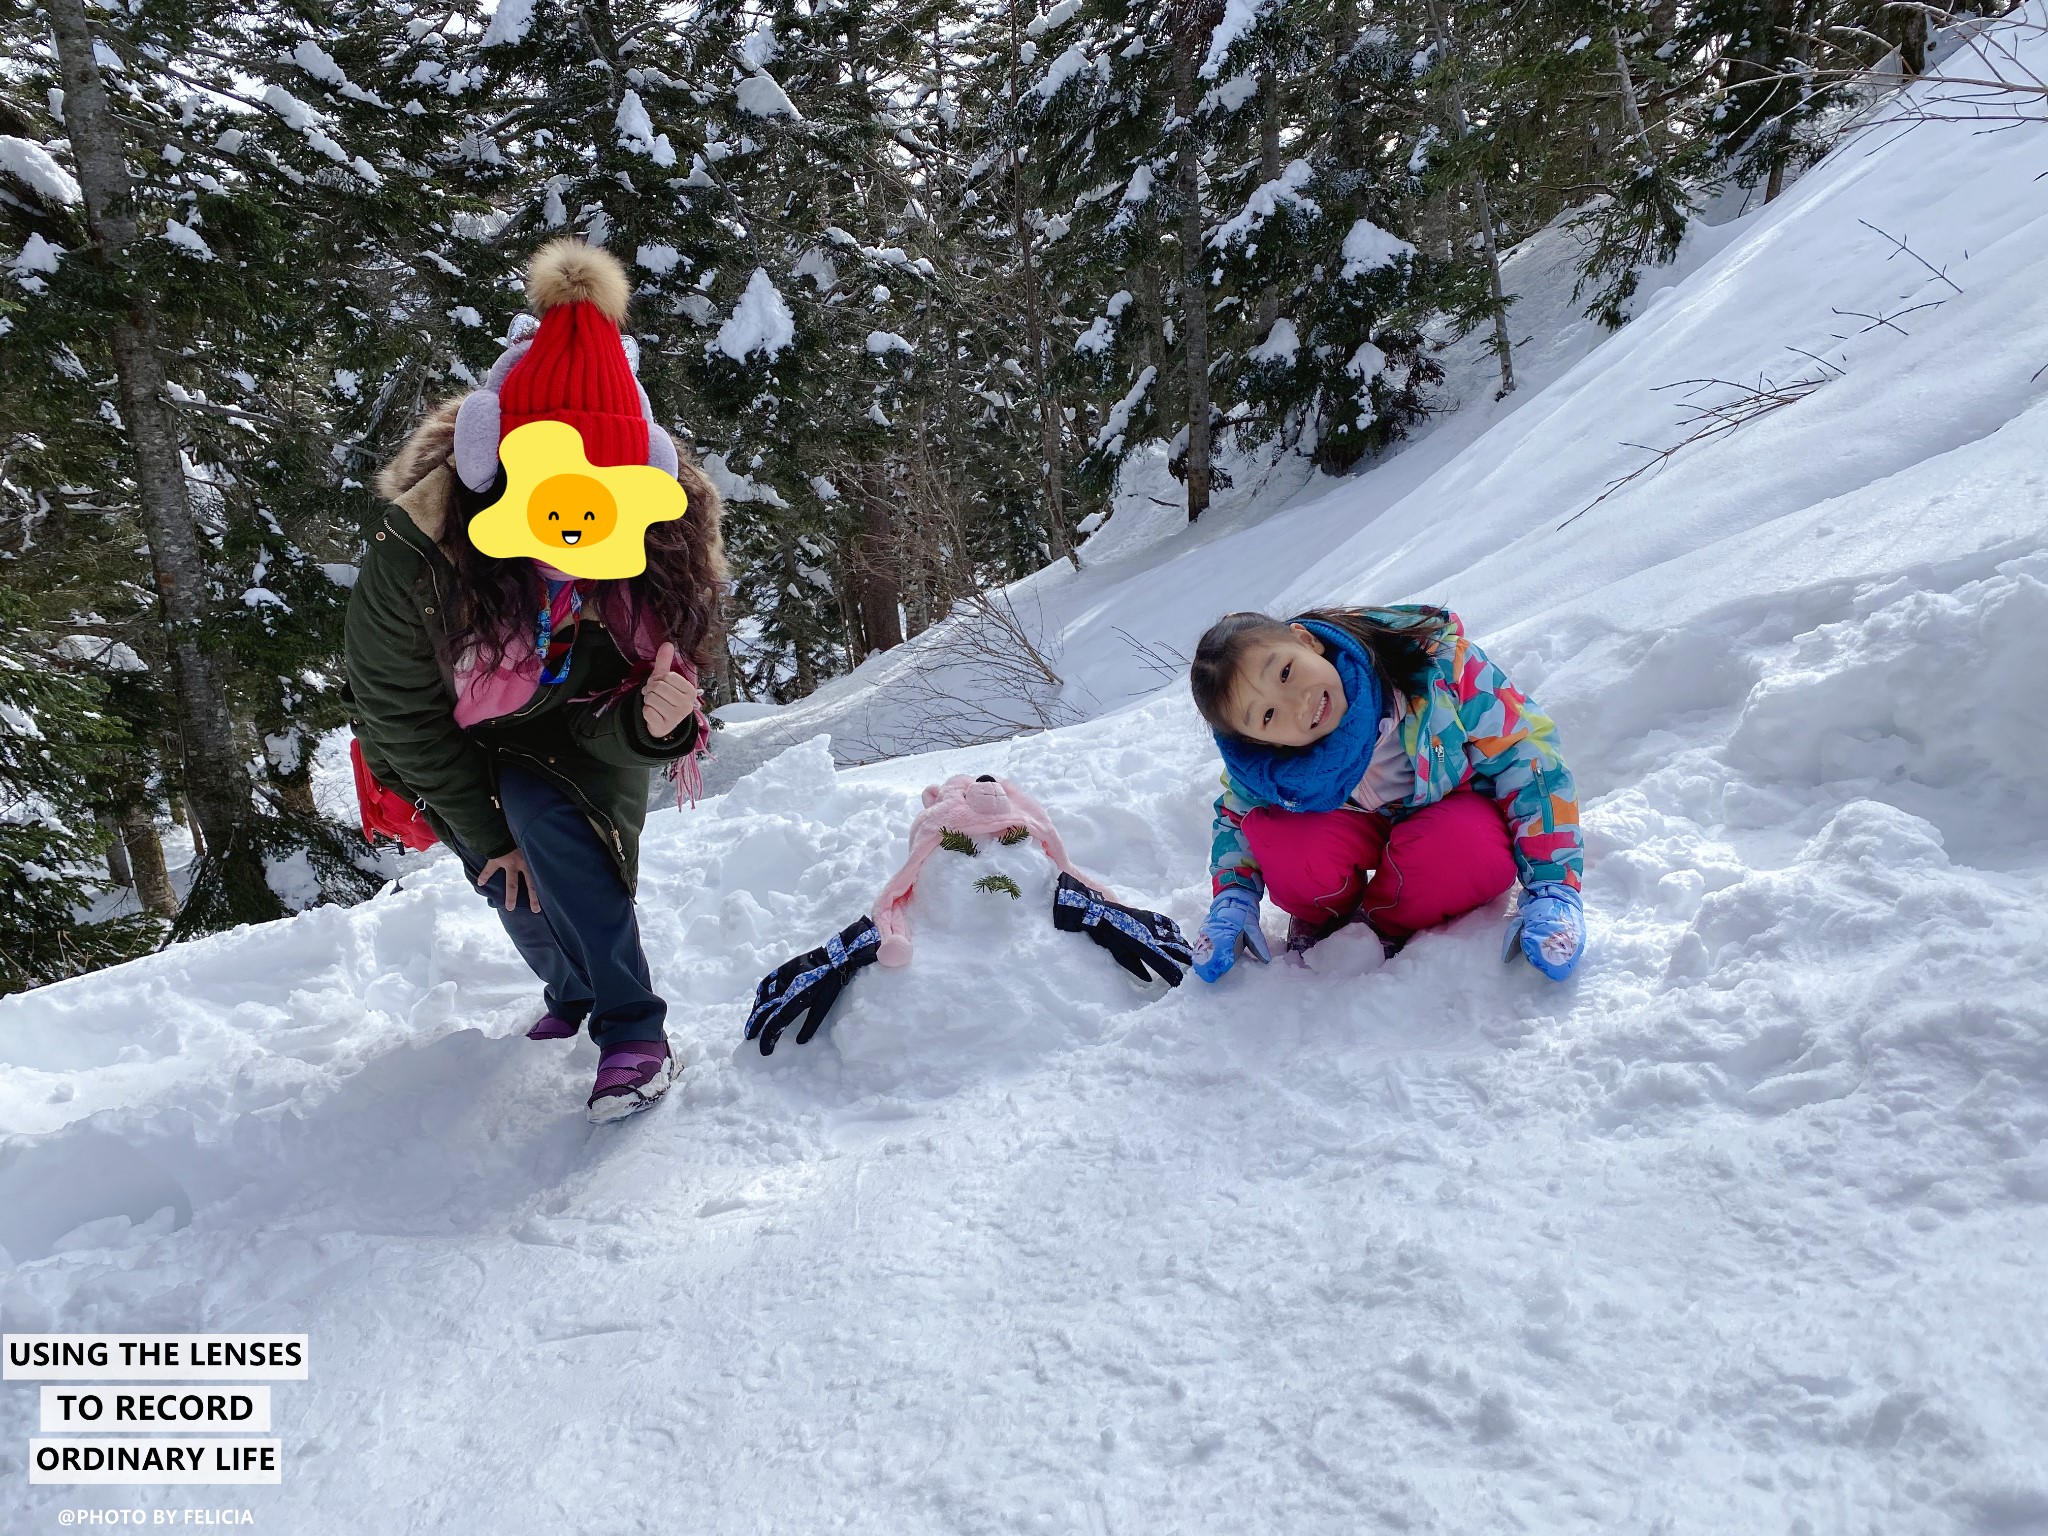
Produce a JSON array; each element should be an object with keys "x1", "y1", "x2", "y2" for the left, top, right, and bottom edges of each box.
[{"x1": 455, "y1": 762, "x2": 668, "y2": 1051}]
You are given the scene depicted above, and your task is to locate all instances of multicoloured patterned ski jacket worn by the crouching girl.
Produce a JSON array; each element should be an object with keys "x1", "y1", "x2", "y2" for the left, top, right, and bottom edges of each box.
[{"x1": 1208, "y1": 606, "x2": 1585, "y2": 895}]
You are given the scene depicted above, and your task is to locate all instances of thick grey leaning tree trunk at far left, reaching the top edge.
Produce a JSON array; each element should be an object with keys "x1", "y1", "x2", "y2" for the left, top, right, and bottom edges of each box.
[{"x1": 47, "y1": 0, "x2": 270, "y2": 901}]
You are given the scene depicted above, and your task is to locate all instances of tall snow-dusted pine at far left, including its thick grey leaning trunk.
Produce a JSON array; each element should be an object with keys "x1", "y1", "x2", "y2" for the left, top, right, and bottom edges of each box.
[{"x1": 0, "y1": 0, "x2": 499, "y2": 932}]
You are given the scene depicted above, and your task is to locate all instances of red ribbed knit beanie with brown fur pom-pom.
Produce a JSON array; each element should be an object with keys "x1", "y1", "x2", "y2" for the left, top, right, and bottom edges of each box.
[{"x1": 498, "y1": 240, "x2": 647, "y2": 465}]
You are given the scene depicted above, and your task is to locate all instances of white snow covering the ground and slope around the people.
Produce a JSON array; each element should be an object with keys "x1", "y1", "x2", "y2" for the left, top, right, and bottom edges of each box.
[{"x1": 0, "y1": 27, "x2": 2048, "y2": 1536}]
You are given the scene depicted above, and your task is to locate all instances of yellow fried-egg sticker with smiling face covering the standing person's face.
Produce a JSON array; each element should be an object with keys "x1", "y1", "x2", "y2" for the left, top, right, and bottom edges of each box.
[{"x1": 469, "y1": 422, "x2": 690, "y2": 580}]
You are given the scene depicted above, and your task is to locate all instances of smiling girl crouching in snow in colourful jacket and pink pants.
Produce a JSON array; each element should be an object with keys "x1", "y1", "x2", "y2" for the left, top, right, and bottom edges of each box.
[{"x1": 1190, "y1": 606, "x2": 1585, "y2": 981}]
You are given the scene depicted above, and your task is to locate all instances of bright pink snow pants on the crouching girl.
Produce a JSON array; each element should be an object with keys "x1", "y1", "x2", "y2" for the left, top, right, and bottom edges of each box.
[{"x1": 1243, "y1": 788, "x2": 1516, "y2": 942}]
